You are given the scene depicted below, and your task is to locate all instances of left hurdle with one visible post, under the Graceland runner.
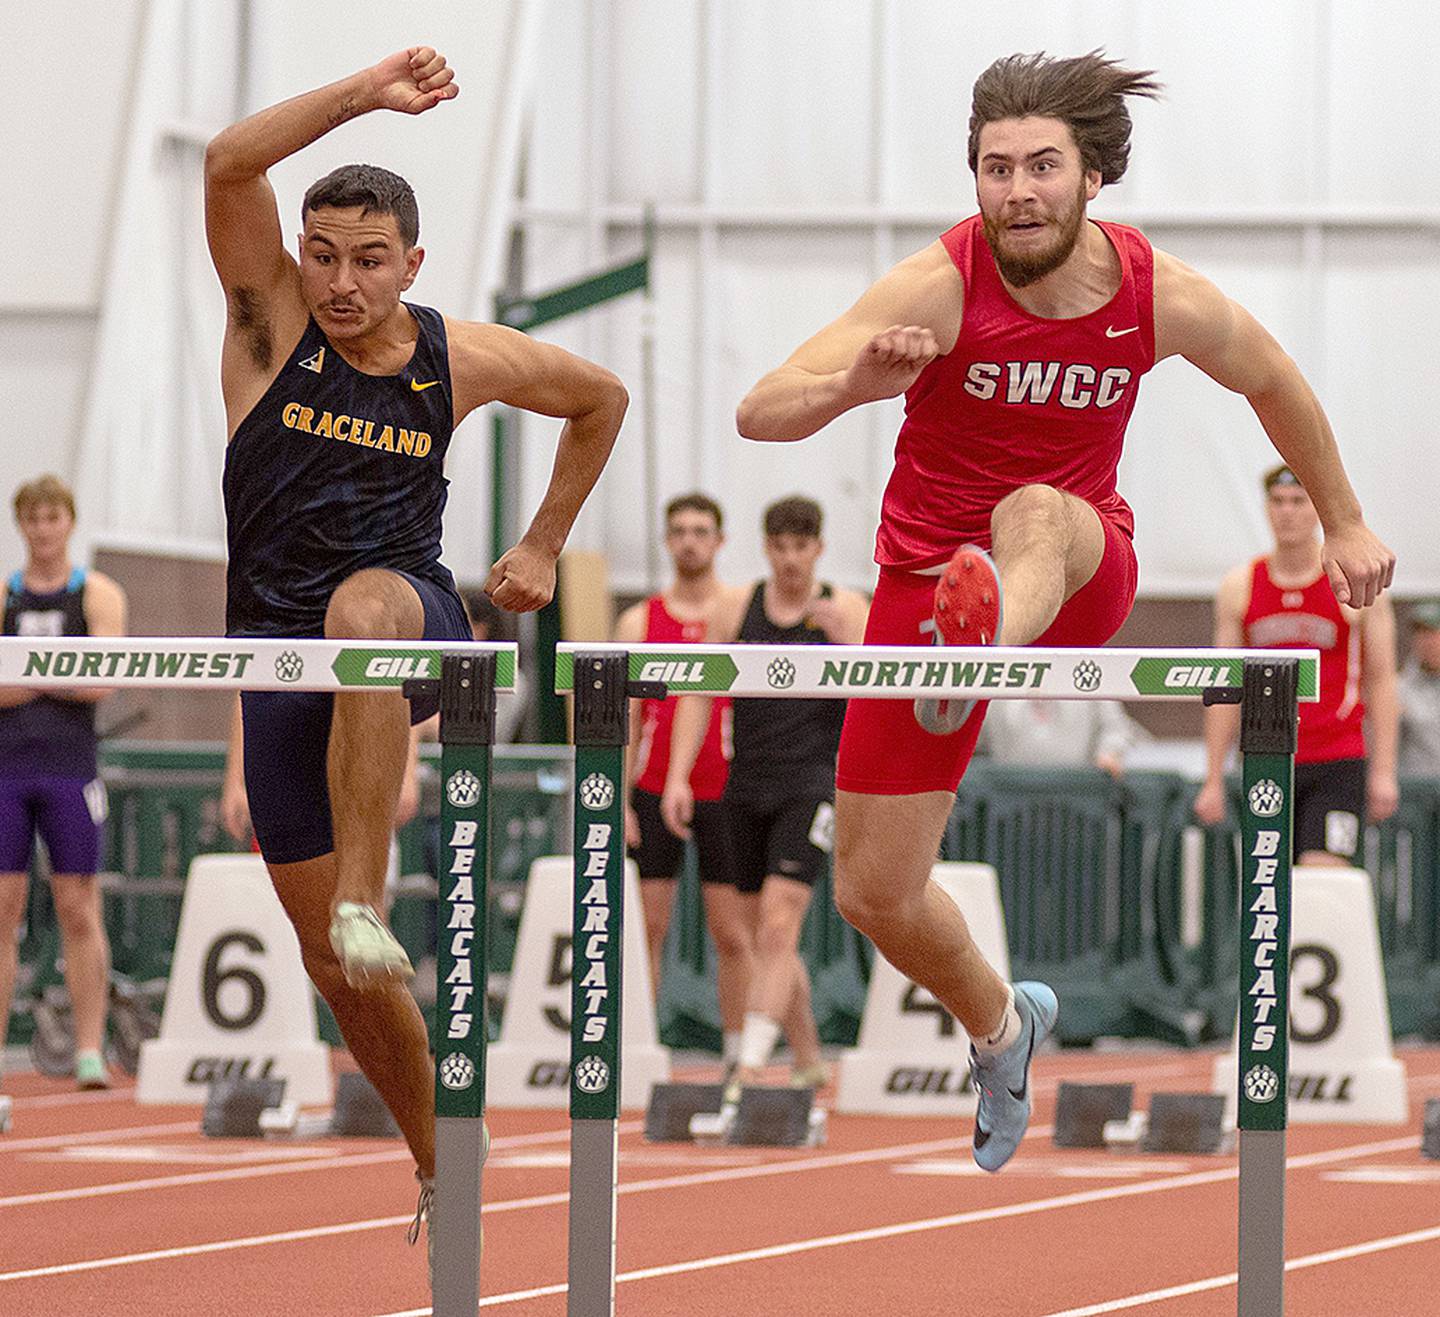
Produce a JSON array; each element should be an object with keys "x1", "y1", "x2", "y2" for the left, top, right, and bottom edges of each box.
[{"x1": 0, "y1": 636, "x2": 517, "y2": 1317}]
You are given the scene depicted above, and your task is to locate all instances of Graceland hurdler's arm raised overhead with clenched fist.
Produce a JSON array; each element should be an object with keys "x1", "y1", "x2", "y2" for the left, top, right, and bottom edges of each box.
[{"x1": 204, "y1": 46, "x2": 459, "y2": 410}]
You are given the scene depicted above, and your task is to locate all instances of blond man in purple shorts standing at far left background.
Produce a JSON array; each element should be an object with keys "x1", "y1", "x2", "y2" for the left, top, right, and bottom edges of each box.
[{"x1": 0, "y1": 475, "x2": 125, "y2": 1088}]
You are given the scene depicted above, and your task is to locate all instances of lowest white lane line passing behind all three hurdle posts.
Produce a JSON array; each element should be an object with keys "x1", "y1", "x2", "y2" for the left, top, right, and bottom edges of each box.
[{"x1": 368, "y1": 1139, "x2": 1414, "y2": 1317}]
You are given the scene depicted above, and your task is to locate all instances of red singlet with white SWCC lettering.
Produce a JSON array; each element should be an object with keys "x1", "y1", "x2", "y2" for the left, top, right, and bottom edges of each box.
[{"x1": 876, "y1": 214, "x2": 1155, "y2": 570}]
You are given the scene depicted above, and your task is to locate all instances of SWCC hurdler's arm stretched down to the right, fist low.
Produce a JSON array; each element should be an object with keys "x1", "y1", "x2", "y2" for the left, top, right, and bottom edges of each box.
[{"x1": 1155, "y1": 252, "x2": 1395, "y2": 607}]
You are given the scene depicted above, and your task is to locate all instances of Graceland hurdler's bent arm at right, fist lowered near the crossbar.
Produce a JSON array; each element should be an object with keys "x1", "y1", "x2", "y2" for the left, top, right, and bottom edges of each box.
[{"x1": 446, "y1": 329, "x2": 629, "y2": 613}]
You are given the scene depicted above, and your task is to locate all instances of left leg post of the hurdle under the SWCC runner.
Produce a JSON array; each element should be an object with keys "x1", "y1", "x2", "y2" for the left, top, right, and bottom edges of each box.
[{"x1": 566, "y1": 652, "x2": 629, "y2": 1317}]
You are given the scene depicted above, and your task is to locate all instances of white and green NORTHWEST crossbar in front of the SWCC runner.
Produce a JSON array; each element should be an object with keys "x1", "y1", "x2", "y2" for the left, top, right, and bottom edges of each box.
[{"x1": 554, "y1": 643, "x2": 1320, "y2": 702}]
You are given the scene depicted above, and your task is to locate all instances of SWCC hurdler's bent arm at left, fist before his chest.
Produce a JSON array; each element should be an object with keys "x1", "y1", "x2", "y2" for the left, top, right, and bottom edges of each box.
[{"x1": 736, "y1": 242, "x2": 965, "y2": 443}]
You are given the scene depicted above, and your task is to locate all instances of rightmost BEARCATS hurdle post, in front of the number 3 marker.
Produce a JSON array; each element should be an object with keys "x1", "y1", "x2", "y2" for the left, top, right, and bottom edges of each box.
[{"x1": 1236, "y1": 659, "x2": 1300, "y2": 1317}]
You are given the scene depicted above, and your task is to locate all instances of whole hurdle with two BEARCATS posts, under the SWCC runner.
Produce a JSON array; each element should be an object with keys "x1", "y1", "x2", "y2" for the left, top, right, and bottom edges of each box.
[{"x1": 558, "y1": 642, "x2": 1319, "y2": 1317}]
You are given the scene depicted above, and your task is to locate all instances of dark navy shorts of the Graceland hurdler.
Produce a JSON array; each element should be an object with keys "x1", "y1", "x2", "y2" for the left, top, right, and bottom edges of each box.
[{"x1": 240, "y1": 571, "x2": 474, "y2": 864}]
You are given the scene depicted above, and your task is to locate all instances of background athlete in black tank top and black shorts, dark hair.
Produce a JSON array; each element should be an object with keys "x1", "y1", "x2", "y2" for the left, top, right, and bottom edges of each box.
[{"x1": 661, "y1": 497, "x2": 868, "y2": 1084}]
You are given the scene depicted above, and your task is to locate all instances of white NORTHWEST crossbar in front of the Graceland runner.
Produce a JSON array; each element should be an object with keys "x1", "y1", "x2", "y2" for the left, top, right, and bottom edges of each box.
[{"x1": 0, "y1": 636, "x2": 516, "y2": 691}]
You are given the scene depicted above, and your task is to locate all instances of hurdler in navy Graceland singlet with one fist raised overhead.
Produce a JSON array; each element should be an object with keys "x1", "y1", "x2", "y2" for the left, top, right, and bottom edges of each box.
[{"x1": 204, "y1": 46, "x2": 626, "y2": 1206}]
